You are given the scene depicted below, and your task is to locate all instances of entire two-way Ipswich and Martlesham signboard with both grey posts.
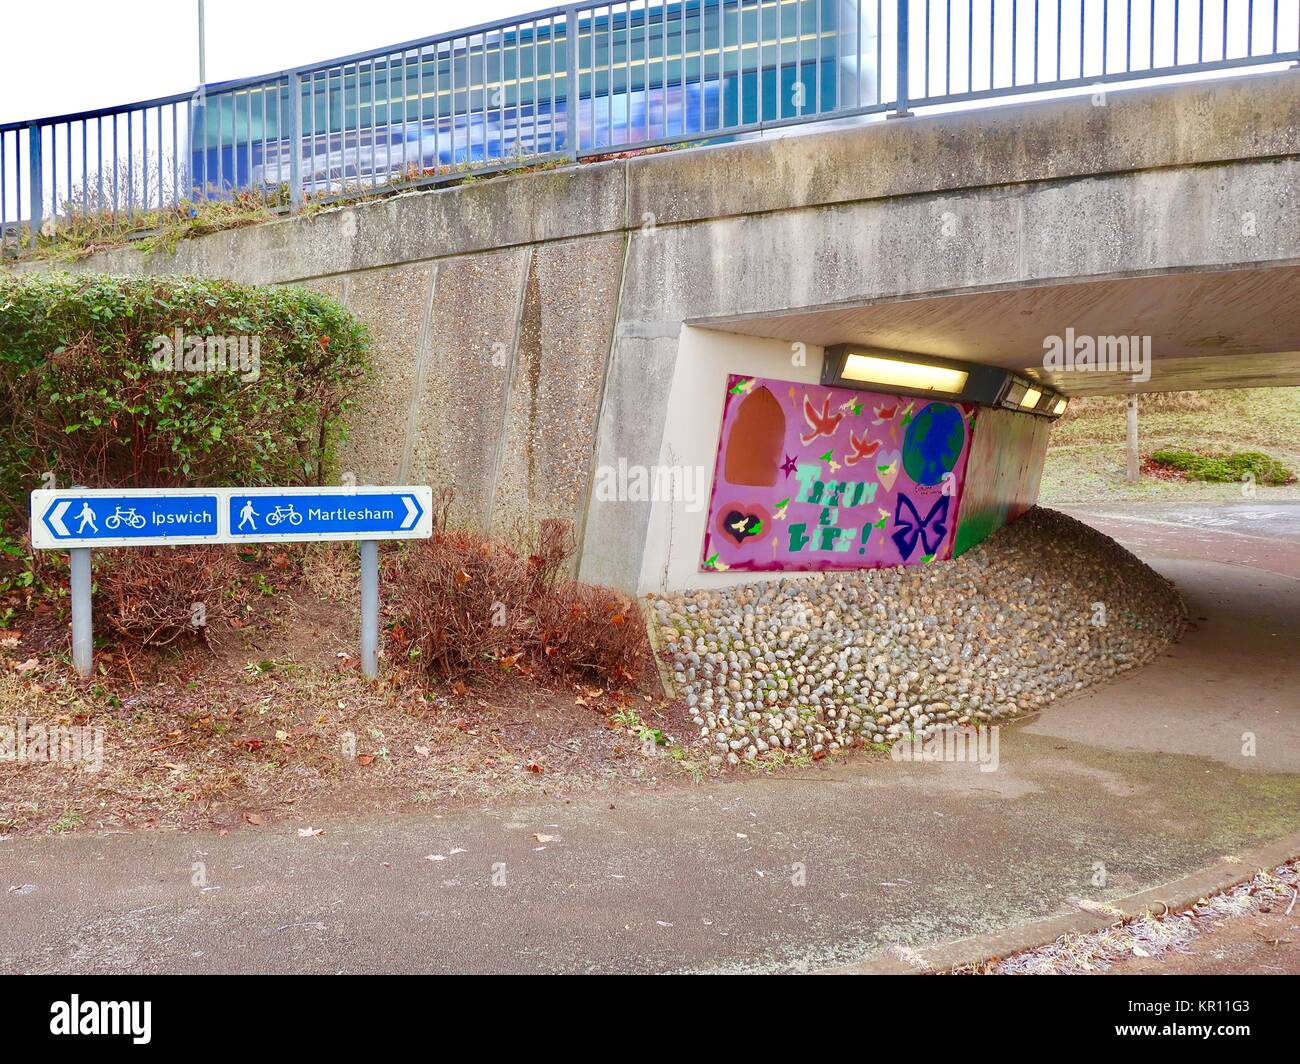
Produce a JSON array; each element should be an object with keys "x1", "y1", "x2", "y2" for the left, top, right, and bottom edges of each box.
[{"x1": 31, "y1": 486, "x2": 433, "y2": 678}]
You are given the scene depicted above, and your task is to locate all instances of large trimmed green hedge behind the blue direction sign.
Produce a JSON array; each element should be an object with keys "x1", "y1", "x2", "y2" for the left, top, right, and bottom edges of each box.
[{"x1": 0, "y1": 273, "x2": 368, "y2": 515}]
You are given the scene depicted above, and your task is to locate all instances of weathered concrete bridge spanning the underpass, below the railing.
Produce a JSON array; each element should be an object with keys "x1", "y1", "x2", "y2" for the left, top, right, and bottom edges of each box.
[{"x1": 29, "y1": 70, "x2": 1300, "y2": 589}]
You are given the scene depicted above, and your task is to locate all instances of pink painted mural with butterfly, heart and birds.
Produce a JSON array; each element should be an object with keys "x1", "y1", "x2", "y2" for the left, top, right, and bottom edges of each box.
[{"x1": 701, "y1": 375, "x2": 974, "y2": 572}]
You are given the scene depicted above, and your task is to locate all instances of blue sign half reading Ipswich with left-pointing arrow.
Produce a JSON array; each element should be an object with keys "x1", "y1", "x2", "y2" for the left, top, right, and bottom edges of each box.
[{"x1": 31, "y1": 490, "x2": 220, "y2": 548}]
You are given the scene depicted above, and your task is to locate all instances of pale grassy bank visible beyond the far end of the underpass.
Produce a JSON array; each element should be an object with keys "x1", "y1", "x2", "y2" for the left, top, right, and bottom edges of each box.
[{"x1": 1039, "y1": 388, "x2": 1300, "y2": 506}]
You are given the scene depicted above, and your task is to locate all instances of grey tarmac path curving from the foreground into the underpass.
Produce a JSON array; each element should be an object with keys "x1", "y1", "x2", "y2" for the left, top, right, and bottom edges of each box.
[{"x1": 0, "y1": 506, "x2": 1300, "y2": 972}]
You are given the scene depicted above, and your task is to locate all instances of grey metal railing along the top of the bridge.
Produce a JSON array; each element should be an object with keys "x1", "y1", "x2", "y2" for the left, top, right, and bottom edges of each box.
[{"x1": 0, "y1": 0, "x2": 1300, "y2": 254}]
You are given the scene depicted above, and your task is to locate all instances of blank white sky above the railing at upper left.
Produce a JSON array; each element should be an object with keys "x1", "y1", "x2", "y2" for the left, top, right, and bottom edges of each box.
[{"x1": 0, "y1": 0, "x2": 535, "y2": 122}]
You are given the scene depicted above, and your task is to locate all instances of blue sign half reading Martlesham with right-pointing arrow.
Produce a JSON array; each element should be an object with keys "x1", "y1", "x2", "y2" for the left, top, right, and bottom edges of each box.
[{"x1": 226, "y1": 489, "x2": 428, "y2": 540}]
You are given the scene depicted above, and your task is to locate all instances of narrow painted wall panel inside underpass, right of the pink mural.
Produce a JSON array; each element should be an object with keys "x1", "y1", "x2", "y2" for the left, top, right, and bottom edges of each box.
[{"x1": 953, "y1": 410, "x2": 1052, "y2": 558}]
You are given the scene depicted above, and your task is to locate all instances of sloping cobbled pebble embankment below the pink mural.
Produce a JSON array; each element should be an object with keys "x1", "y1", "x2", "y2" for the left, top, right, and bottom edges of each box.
[{"x1": 651, "y1": 509, "x2": 1187, "y2": 765}]
